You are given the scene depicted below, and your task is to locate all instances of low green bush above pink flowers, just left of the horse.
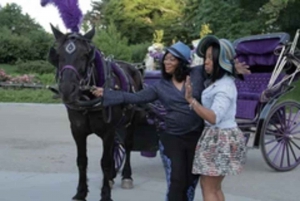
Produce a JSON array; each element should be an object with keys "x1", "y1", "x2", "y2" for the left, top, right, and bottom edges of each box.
[{"x1": 16, "y1": 60, "x2": 56, "y2": 74}]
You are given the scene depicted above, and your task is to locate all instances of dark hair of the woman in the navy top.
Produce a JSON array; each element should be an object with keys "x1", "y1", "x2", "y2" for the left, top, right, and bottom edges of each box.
[{"x1": 161, "y1": 51, "x2": 191, "y2": 82}]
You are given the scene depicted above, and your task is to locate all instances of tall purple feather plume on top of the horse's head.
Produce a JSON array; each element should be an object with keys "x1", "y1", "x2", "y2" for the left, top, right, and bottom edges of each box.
[{"x1": 41, "y1": 0, "x2": 83, "y2": 32}]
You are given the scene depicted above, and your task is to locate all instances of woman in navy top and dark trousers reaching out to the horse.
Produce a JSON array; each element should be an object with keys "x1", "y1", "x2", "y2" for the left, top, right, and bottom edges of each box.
[{"x1": 93, "y1": 42, "x2": 245, "y2": 201}]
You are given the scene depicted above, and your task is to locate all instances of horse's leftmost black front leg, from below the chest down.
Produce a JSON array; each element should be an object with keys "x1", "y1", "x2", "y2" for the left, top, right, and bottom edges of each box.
[{"x1": 72, "y1": 131, "x2": 88, "y2": 201}]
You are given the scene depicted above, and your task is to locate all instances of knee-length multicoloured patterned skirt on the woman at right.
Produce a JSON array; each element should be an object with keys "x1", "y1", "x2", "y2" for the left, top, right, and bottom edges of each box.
[{"x1": 192, "y1": 127, "x2": 247, "y2": 176}]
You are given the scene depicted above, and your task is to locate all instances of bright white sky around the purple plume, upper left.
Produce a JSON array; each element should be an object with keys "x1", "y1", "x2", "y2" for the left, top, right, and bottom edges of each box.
[{"x1": 0, "y1": 0, "x2": 91, "y2": 32}]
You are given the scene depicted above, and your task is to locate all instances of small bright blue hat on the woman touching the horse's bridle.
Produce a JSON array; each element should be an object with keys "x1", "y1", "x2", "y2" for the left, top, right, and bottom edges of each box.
[{"x1": 166, "y1": 41, "x2": 191, "y2": 63}]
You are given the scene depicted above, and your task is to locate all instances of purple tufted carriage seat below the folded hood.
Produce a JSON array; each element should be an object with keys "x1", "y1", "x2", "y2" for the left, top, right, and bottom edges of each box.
[{"x1": 235, "y1": 73, "x2": 272, "y2": 119}]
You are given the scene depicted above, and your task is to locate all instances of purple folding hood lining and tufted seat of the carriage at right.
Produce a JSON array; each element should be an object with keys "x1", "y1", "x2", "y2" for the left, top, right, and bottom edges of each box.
[{"x1": 233, "y1": 33, "x2": 289, "y2": 119}]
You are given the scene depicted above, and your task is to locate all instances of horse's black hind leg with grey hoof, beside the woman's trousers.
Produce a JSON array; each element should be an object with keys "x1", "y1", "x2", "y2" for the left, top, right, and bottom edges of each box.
[{"x1": 121, "y1": 124, "x2": 135, "y2": 189}]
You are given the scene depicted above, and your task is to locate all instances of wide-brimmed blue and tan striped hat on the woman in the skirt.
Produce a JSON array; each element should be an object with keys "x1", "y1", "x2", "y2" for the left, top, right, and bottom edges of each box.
[{"x1": 196, "y1": 35, "x2": 236, "y2": 74}]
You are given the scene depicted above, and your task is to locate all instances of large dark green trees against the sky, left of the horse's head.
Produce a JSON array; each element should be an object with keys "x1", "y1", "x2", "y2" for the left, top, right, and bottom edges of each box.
[{"x1": 0, "y1": 3, "x2": 52, "y2": 63}]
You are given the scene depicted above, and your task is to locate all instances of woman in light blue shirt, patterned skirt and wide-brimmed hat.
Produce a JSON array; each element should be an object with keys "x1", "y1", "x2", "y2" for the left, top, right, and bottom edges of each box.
[{"x1": 185, "y1": 35, "x2": 246, "y2": 201}]
